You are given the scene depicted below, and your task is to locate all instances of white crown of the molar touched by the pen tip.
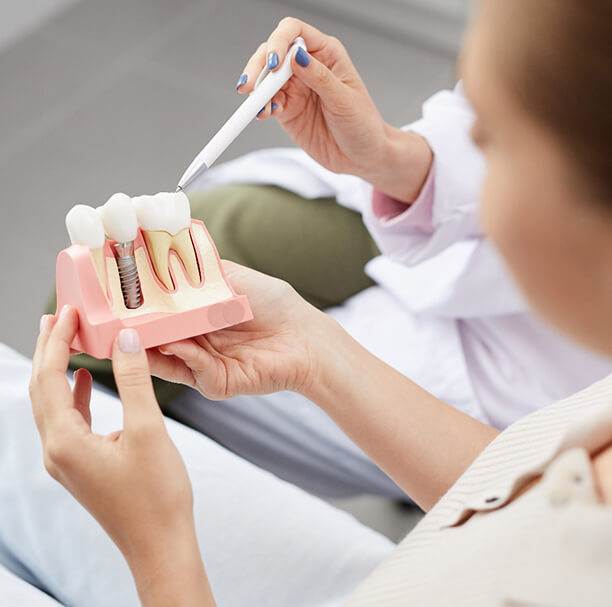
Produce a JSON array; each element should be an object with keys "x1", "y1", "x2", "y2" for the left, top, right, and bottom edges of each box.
[{"x1": 132, "y1": 192, "x2": 191, "y2": 236}]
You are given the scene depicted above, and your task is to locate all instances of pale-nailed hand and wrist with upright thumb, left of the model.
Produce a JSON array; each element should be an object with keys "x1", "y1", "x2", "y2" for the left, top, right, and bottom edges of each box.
[{"x1": 30, "y1": 308, "x2": 214, "y2": 606}]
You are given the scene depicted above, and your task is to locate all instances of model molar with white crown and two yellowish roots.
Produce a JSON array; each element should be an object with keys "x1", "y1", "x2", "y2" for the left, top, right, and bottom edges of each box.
[{"x1": 132, "y1": 192, "x2": 200, "y2": 291}]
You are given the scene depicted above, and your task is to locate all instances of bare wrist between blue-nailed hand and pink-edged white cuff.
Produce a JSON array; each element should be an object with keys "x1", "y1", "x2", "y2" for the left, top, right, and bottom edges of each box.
[{"x1": 361, "y1": 125, "x2": 433, "y2": 204}]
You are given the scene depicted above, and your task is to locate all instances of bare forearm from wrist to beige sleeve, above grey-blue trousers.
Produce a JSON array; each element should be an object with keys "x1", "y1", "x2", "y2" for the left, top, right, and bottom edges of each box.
[{"x1": 305, "y1": 319, "x2": 498, "y2": 510}]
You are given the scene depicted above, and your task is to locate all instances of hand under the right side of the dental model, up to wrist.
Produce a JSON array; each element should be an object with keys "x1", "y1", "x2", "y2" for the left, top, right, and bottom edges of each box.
[{"x1": 149, "y1": 261, "x2": 333, "y2": 400}]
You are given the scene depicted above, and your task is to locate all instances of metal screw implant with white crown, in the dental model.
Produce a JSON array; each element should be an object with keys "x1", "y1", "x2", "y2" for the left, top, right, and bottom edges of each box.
[{"x1": 96, "y1": 194, "x2": 142, "y2": 309}]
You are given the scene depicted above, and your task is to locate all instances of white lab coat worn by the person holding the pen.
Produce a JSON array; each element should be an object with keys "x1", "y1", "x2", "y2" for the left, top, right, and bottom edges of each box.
[{"x1": 191, "y1": 84, "x2": 612, "y2": 428}]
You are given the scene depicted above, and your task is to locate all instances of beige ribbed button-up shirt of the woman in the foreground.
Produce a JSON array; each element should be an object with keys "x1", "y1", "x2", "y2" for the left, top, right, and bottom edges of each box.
[{"x1": 347, "y1": 376, "x2": 612, "y2": 607}]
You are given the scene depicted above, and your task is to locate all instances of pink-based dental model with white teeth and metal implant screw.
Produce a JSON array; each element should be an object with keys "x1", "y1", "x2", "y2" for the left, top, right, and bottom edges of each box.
[{"x1": 56, "y1": 192, "x2": 253, "y2": 358}]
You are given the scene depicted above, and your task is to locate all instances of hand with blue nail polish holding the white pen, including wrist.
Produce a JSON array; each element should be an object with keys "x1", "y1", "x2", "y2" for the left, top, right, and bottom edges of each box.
[{"x1": 238, "y1": 17, "x2": 432, "y2": 202}]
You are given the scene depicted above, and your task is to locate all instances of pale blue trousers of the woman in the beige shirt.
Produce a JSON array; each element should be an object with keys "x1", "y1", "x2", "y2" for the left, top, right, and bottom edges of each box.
[{"x1": 0, "y1": 344, "x2": 394, "y2": 607}]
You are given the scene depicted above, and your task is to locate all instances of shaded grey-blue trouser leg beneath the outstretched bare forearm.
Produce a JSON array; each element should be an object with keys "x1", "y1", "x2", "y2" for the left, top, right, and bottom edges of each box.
[{"x1": 164, "y1": 390, "x2": 408, "y2": 500}]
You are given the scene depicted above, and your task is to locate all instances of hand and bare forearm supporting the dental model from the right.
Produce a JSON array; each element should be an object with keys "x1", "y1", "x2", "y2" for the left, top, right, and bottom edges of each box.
[{"x1": 149, "y1": 262, "x2": 497, "y2": 509}]
